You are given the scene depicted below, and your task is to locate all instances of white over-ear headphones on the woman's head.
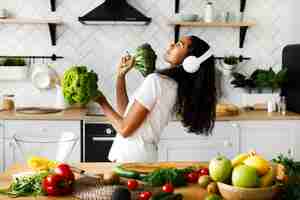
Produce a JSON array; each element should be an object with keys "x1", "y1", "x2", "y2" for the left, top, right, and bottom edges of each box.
[{"x1": 182, "y1": 49, "x2": 213, "y2": 73}]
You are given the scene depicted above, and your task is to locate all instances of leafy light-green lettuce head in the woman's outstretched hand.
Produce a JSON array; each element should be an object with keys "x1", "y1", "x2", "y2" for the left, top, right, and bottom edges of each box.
[{"x1": 62, "y1": 66, "x2": 101, "y2": 105}]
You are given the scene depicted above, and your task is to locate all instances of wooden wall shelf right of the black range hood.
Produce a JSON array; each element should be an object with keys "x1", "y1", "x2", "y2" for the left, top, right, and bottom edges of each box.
[{"x1": 169, "y1": 21, "x2": 255, "y2": 28}]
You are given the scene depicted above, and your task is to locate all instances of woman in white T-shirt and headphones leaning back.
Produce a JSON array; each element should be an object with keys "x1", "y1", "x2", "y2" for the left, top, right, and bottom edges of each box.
[{"x1": 96, "y1": 36, "x2": 216, "y2": 162}]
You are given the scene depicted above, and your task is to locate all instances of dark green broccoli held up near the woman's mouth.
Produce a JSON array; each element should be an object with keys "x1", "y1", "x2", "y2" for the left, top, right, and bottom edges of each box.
[{"x1": 134, "y1": 43, "x2": 157, "y2": 77}]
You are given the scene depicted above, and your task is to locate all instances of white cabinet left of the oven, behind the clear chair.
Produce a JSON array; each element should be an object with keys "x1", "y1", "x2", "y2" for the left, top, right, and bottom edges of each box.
[{"x1": 4, "y1": 120, "x2": 81, "y2": 168}]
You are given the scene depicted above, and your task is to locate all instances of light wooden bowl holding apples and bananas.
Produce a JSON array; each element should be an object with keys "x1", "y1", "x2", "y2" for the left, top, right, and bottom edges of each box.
[{"x1": 217, "y1": 182, "x2": 279, "y2": 200}]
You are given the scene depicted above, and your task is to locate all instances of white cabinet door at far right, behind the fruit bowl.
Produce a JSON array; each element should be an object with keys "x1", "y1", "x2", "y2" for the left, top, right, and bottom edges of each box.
[{"x1": 239, "y1": 120, "x2": 300, "y2": 159}]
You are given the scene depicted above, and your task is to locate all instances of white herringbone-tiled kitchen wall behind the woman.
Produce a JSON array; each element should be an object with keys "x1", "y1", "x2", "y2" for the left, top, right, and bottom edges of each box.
[{"x1": 0, "y1": 0, "x2": 300, "y2": 108}]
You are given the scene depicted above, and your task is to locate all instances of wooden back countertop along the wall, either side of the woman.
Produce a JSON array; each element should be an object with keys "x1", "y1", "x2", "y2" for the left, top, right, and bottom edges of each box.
[{"x1": 0, "y1": 108, "x2": 300, "y2": 122}]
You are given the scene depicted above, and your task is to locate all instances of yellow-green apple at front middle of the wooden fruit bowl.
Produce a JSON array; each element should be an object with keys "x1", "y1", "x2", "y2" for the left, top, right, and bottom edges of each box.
[{"x1": 232, "y1": 165, "x2": 259, "y2": 188}]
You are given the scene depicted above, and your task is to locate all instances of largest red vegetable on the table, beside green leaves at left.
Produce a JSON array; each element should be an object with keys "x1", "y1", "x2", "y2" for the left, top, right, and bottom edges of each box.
[{"x1": 42, "y1": 174, "x2": 72, "y2": 196}]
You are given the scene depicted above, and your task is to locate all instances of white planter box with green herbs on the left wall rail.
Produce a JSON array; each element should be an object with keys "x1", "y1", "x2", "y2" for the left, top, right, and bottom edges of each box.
[{"x1": 0, "y1": 58, "x2": 28, "y2": 80}]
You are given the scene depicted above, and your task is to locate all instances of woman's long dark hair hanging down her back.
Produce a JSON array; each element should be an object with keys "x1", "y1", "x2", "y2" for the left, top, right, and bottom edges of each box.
[{"x1": 158, "y1": 36, "x2": 217, "y2": 135}]
